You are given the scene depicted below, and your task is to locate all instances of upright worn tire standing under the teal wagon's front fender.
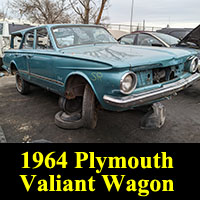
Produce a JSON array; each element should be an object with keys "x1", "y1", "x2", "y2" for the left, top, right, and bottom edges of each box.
[{"x1": 82, "y1": 84, "x2": 97, "y2": 129}]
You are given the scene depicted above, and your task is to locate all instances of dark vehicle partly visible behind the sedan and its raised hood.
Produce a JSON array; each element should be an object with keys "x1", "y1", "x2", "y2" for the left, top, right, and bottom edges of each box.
[{"x1": 156, "y1": 28, "x2": 192, "y2": 40}]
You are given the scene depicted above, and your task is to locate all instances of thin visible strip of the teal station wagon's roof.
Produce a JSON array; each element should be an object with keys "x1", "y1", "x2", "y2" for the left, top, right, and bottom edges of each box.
[{"x1": 11, "y1": 24, "x2": 103, "y2": 35}]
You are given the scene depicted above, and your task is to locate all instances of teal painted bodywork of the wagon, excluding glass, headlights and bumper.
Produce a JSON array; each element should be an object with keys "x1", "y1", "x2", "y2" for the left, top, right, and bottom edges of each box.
[{"x1": 3, "y1": 24, "x2": 196, "y2": 110}]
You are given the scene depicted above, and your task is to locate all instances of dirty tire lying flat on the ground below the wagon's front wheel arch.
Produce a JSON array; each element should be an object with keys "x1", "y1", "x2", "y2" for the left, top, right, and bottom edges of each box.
[{"x1": 55, "y1": 111, "x2": 84, "y2": 130}]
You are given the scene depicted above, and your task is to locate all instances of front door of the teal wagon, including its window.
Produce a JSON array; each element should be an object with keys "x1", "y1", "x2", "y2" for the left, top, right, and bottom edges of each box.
[{"x1": 29, "y1": 28, "x2": 56, "y2": 90}]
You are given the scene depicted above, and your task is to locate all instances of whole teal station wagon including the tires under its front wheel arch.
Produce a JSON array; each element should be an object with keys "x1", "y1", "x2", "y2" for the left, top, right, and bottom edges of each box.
[{"x1": 3, "y1": 24, "x2": 200, "y2": 129}]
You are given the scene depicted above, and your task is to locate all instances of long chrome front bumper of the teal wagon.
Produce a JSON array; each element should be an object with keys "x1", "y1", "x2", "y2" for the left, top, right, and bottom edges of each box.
[{"x1": 103, "y1": 73, "x2": 200, "y2": 108}]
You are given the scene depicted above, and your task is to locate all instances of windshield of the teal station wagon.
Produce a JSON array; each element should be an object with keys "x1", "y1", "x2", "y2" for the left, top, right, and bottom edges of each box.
[{"x1": 53, "y1": 26, "x2": 117, "y2": 48}]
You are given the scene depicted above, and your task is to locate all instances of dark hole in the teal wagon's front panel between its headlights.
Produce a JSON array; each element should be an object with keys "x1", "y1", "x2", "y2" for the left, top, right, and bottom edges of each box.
[{"x1": 153, "y1": 67, "x2": 177, "y2": 84}]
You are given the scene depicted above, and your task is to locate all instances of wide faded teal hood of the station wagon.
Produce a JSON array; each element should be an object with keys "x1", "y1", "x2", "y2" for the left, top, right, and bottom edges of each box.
[{"x1": 60, "y1": 44, "x2": 192, "y2": 67}]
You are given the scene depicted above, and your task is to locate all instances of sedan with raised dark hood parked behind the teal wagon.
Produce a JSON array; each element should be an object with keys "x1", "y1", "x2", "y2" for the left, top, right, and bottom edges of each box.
[{"x1": 118, "y1": 26, "x2": 200, "y2": 58}]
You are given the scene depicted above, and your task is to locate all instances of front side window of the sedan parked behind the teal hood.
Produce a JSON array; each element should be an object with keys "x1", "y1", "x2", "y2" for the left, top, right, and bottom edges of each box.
[{"x1": 137, "y1": 34, "x2": 163, "y2": 46}]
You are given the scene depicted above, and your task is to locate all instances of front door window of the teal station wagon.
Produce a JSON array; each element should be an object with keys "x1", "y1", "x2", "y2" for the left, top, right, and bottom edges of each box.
[{"x1": 36, "y1": 28, "x2": 53, "y2": 49}]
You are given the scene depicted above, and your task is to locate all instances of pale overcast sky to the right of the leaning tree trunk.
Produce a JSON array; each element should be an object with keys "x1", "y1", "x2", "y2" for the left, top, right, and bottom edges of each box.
[{"x1": 106, "y1": 0, "x2": 200, "y2": 27}]
